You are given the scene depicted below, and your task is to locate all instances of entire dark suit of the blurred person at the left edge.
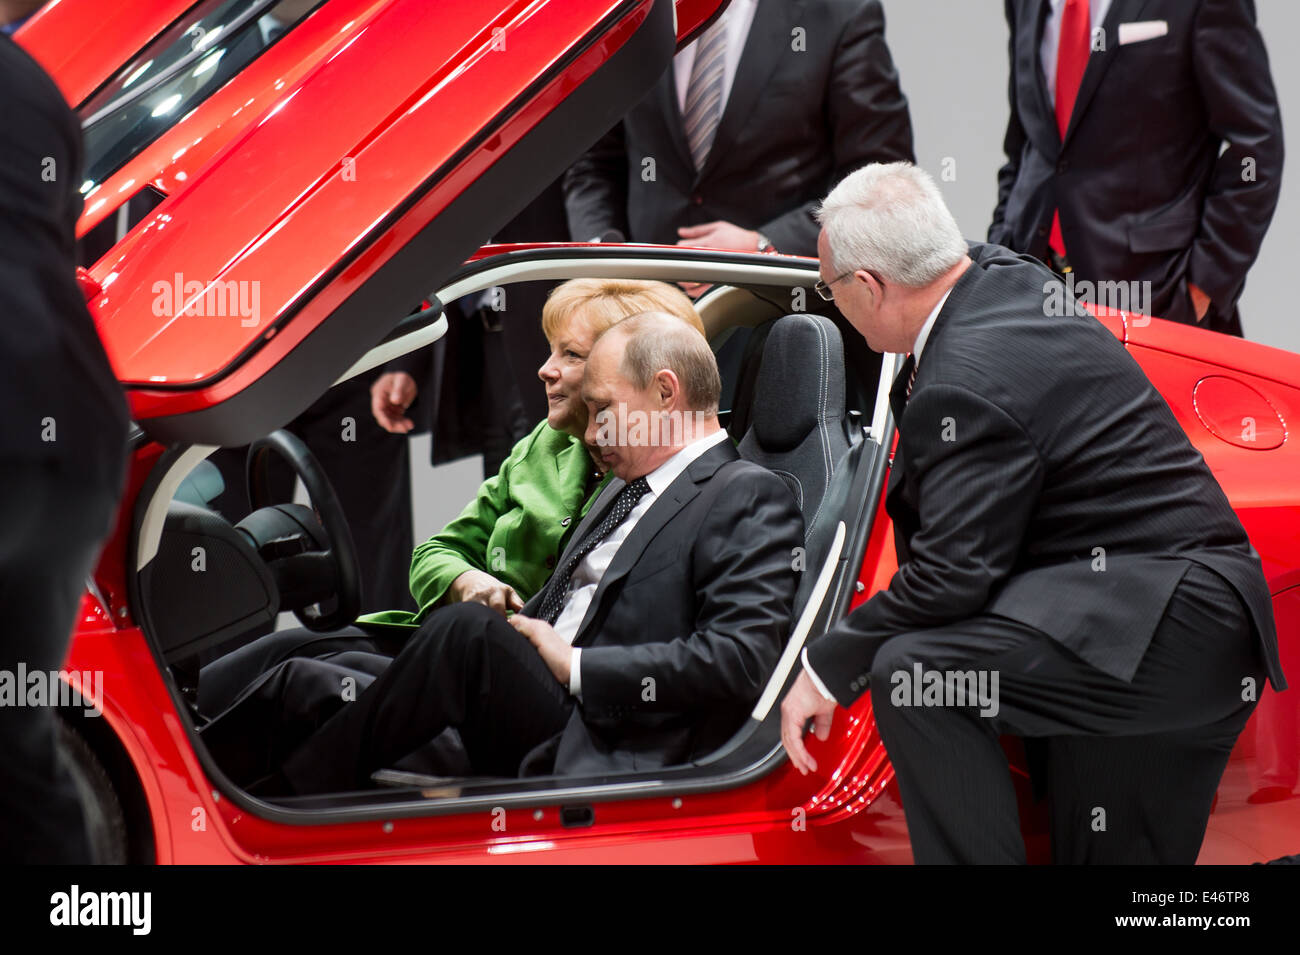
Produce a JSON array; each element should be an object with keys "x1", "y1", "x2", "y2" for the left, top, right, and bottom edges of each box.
[{"x1": 0, "y1": 36, "x2": 127, "y2": 863}]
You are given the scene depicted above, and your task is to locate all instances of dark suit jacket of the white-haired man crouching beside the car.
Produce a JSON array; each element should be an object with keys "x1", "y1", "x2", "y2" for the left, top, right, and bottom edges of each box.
[{"x1": 809, "y1": 246, "x2": 1284, "y2": 706}]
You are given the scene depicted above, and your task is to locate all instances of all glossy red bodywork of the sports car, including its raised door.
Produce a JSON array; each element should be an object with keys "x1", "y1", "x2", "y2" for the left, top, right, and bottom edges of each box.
[{"x1": 20, "y1": 0, "x2": 1300, "y2": 863}]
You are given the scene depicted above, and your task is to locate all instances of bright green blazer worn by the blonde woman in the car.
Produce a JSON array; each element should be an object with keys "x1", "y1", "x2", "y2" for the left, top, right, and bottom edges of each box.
[{"x1": 356, "y1": 421, "x2": 610, "y2": 629}]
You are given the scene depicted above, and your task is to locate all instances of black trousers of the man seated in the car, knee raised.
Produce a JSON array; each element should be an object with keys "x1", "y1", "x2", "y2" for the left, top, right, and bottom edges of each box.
[{"x1": 282, "y1": 603, "x2": 573, "y2": 794}]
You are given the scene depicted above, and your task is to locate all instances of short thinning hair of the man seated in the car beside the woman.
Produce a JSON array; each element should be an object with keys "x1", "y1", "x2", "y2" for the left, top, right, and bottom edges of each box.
[{"x1": 610, "y1": 312, "x2": 723, "y2": 414}]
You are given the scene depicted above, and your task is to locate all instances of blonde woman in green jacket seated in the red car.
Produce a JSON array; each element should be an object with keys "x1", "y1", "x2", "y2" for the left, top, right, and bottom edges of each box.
[{"x1": 199, "y1": 278, "x2": 705, "y2": 715}]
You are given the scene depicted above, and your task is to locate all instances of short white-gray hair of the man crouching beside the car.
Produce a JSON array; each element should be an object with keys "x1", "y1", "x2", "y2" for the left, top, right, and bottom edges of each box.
[{"x1": 816, "y1": 162, "x2": 966, "y2": 288}]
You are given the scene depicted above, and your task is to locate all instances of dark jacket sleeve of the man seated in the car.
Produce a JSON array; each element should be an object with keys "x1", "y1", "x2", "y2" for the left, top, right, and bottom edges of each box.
[{"x1": 582, "y1": 472, "x2": 803, "y2": 720}]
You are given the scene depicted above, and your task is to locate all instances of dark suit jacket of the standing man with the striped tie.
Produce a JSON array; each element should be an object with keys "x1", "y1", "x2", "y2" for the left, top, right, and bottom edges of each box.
[{"x1": 564, "y1": 0, "x2": 913, "y2": 256}]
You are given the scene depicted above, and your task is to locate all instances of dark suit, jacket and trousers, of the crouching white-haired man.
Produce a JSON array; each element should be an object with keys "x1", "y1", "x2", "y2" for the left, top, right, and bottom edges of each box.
[{"x1": 809, "y1": 246, "x2": 1284, "y2": 863}]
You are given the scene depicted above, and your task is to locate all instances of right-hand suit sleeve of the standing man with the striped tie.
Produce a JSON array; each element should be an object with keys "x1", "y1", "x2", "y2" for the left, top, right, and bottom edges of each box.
[{"x1": 758, "y1": 0, "x2": 917, "y2": 255}]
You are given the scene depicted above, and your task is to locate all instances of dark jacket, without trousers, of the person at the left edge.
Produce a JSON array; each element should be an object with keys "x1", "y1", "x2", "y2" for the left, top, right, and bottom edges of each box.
[{"x1": 0, "y1": 35, "x2": 127, "y2": 492}]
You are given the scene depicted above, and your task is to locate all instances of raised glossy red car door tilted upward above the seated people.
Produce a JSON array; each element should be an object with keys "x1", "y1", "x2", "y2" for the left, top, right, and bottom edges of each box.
[{"x1": 18, "y1": 0, "x2": 670, "y2": 446}]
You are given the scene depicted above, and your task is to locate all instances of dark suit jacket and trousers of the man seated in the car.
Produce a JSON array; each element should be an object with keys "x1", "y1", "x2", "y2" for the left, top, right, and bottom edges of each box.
[{"x1": 283, "y1": 442, "x2": 803, "y2": 793}]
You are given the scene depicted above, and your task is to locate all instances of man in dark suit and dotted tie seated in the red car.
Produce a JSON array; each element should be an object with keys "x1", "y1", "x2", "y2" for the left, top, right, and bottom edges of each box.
[{"x1": 261, "y1": 312, "x2": 803, "y2": 794}]
